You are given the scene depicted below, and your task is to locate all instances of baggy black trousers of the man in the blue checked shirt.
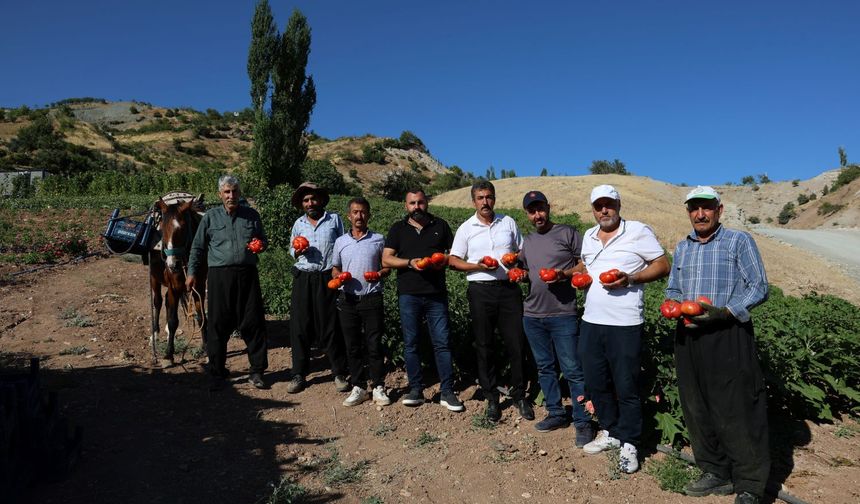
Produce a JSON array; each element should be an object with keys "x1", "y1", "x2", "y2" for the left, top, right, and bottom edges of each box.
[{"x1": 675, "y1": 322, "x2": 770, "y2": 497}]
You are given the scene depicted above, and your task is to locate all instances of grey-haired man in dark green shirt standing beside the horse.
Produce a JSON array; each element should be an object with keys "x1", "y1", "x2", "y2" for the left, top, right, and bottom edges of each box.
[{"x1": 185, "y1": 175, "x2": 269, "y2": 390}]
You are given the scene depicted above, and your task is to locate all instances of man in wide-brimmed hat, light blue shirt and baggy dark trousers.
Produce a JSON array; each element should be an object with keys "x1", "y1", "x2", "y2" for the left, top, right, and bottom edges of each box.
[{"x1": 287, "y1": 182, "x2": 349, "y2": 394}]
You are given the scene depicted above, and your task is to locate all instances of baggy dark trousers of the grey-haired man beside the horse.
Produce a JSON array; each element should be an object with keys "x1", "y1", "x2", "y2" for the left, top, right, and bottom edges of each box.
[{"x1": 206, "y1": 266, "x2": 269, "y2": 376}]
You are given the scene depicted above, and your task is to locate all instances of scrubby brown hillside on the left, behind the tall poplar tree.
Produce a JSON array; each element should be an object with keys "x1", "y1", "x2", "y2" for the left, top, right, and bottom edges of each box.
[{"x1": 0, "y1": 100, "x2": 448, "y2": 190}]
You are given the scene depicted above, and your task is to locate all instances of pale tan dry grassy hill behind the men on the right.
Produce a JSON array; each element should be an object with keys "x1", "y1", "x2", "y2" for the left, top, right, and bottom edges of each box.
[{"x1": 433, "y1": 175, "x2": 860, "y2": 304}]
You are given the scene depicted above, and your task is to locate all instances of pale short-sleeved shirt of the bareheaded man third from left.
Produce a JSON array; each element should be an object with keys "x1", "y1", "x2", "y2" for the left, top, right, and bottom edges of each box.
[{"x1": 332, "y1": 229, "x2": 385, "y2": 296}]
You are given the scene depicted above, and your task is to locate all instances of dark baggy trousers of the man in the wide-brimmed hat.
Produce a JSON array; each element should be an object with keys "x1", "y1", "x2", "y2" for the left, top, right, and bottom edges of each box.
[{"x1": 290, "y1": 268, "x2": 348, "y2": 377}]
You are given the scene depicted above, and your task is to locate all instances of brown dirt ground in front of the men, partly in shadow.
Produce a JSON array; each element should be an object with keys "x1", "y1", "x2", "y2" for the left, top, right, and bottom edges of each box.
[{"x1": 0, "y1": 258, "x2": 860, "y2": 504}]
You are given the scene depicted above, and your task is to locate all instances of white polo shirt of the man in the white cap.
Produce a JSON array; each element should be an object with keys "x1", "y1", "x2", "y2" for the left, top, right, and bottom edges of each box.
[{"x1": 582, "y1": 219, "x2": 666, "y2": 326}]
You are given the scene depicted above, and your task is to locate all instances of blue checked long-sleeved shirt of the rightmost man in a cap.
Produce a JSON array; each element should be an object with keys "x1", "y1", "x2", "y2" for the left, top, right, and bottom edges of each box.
[{"x1": 666, "y1": 225, "x2": 767, "y2": 322}]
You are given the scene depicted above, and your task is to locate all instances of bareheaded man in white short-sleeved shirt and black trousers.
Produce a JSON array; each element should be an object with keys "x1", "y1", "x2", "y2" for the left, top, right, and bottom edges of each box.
[{"x1": 450, "y1": 180, "x2": 535, "y2": 422}]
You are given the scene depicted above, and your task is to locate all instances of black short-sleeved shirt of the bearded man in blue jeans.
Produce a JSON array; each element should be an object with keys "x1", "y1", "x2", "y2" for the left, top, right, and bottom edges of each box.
[{"x1": 385, "y1": 215, "x2": 454, "y2": 295}]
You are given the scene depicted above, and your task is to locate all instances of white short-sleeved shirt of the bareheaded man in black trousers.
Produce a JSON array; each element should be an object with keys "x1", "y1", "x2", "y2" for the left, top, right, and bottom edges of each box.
[{"x1": 451, "y1": 213, "x2": 523, "y2": 282}]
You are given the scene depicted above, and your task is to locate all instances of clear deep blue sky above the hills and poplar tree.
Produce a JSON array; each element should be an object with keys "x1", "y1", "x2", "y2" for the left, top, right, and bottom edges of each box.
[{"x1": 0, "y1": 0, "x2": 860, "y2": 184}]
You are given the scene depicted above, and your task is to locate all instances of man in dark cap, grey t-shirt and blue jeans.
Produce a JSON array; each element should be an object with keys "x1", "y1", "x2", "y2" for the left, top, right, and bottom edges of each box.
[{"x1": 519, "y1": 191, "x2": 594, "y2": 448}]
